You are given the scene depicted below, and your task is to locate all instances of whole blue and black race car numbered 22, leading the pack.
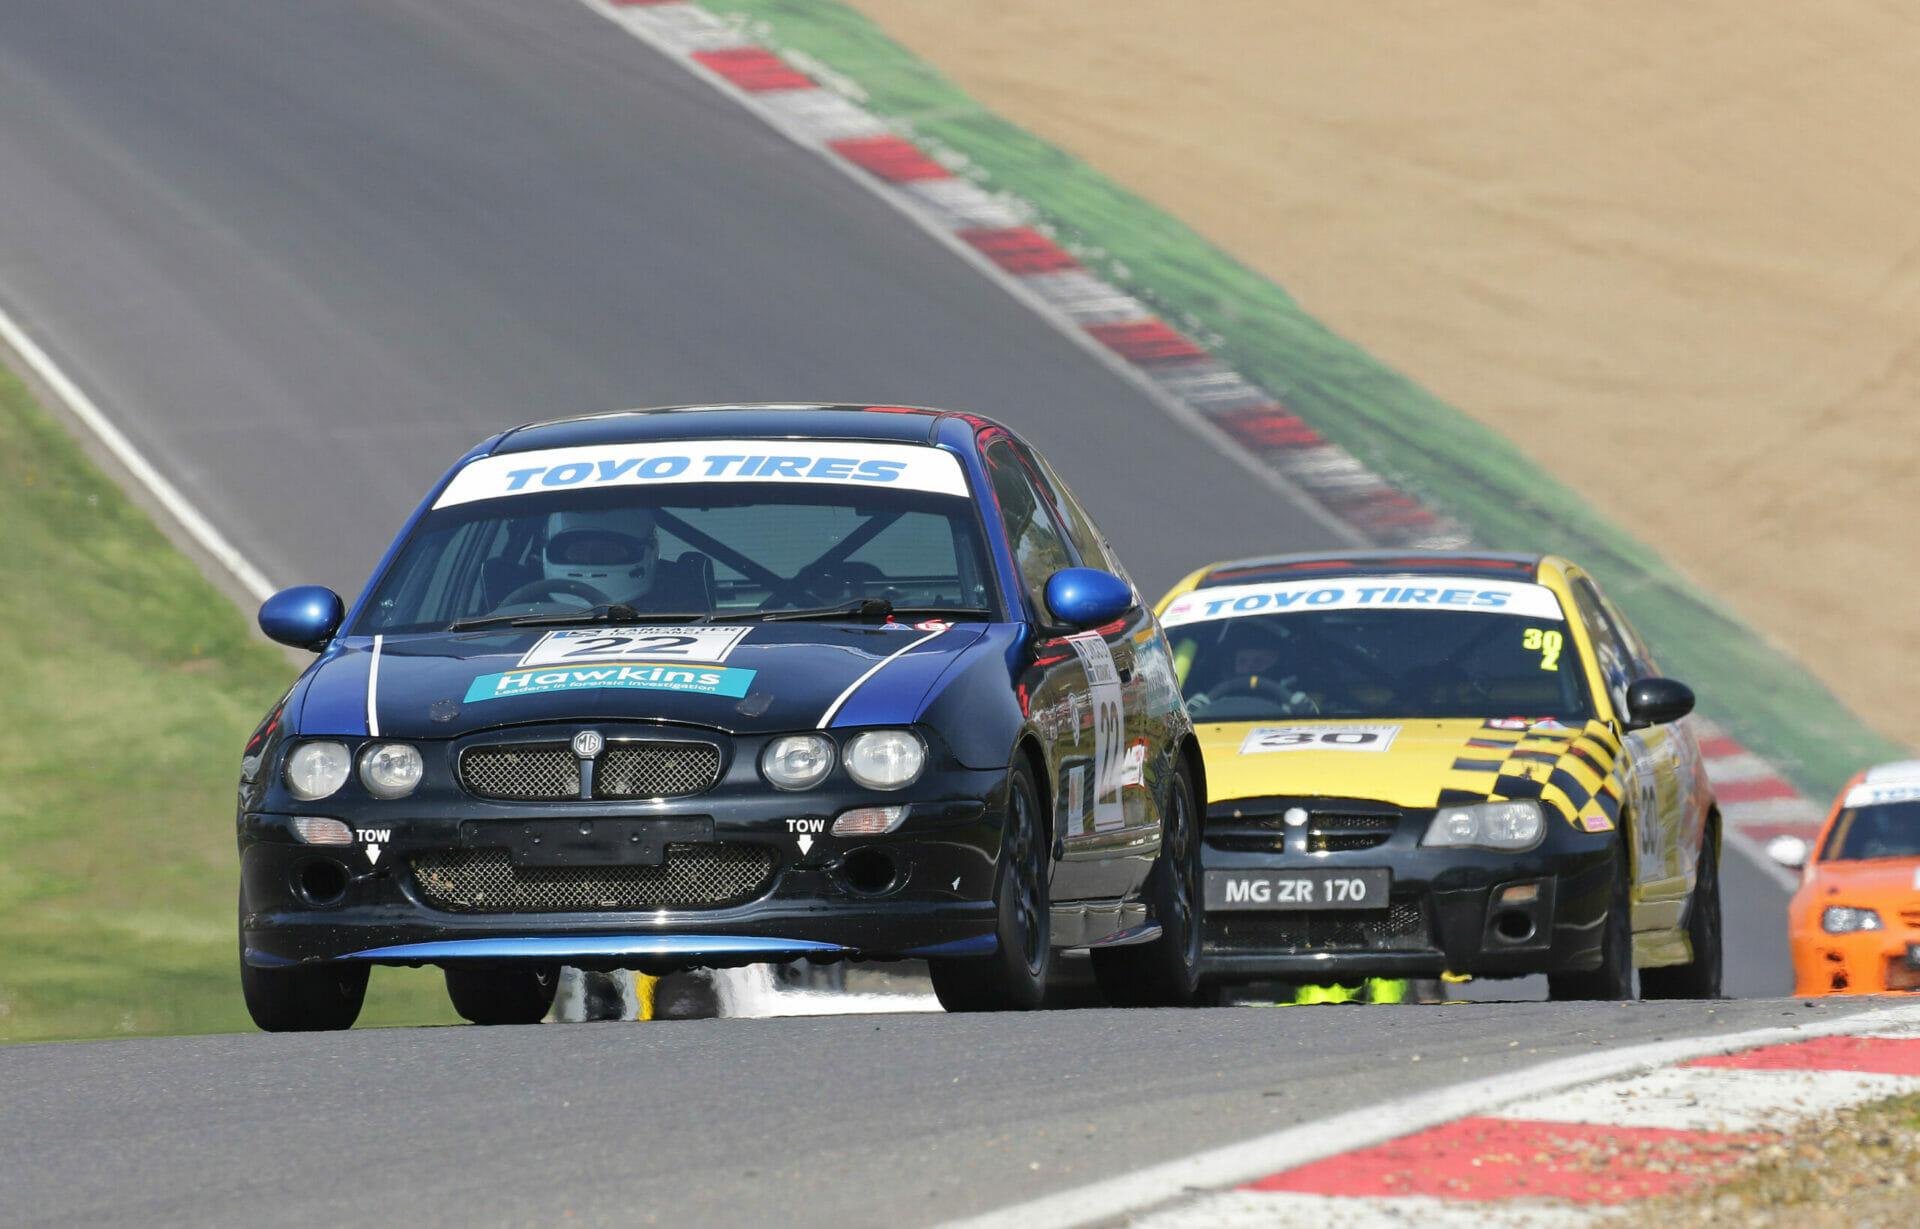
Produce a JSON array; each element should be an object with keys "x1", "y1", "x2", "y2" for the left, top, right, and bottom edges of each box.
[{"x1": 240, "y1": 405, "x2": 1206, "y2": 1029}]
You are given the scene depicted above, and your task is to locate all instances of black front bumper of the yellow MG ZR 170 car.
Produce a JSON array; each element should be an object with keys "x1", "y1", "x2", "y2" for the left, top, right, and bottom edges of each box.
[{"x1": 1200, "y1": 799, "x2": 1619, "y2": 983}]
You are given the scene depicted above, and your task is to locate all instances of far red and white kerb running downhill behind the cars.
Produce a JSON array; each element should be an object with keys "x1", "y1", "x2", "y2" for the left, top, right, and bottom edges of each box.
[{"x1": 584, "y1": 0, "x2": 1822, "y2": 852}]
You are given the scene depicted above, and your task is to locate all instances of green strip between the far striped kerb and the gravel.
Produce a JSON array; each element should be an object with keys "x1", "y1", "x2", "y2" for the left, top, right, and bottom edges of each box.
[{"x1": 707, "y1": 0, "x2": 1908, "y2": 801}]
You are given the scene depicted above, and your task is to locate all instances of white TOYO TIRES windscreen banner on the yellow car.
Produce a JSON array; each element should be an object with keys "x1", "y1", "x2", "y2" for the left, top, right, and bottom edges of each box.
[{"x1": 1160, "y1": 576, "x2": 1565, "y2": 628}]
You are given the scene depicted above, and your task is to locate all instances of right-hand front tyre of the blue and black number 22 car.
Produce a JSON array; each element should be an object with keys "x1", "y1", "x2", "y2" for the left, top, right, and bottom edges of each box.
[{"x1": 927, "y1": 759, "x2": 1054, "y2": 1012}]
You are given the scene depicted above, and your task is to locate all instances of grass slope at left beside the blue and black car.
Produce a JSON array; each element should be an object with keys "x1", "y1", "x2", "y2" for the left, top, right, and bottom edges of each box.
[{"x1": 0, "y1": 369, "x2": 455, "y2": 1041}]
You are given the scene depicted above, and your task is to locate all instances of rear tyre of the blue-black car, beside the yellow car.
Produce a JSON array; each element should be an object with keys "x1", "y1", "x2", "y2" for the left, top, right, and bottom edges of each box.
[{"x1": 1091, "y1": 764, "x2": 1202, "y2": 1006}]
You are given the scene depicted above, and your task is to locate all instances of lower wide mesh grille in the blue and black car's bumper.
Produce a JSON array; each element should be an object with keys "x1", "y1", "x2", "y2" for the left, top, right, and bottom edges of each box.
[{"x1": 413, "y1": 843, "x2": 774, "y2": 914}]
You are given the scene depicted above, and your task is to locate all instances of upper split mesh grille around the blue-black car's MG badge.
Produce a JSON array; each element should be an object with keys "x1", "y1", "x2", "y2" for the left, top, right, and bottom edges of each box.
[{"x1": 461, "y1": 739, "x2": 720, "y2": 803}]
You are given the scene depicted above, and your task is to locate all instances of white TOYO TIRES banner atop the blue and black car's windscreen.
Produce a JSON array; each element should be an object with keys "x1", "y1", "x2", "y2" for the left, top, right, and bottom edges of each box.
[{"x1": 434, "y1": 440, "x2": 966, "y2": 507}]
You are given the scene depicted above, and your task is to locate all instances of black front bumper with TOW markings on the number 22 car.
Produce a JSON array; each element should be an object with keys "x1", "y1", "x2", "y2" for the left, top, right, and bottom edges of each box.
[{"x1": 240, "y1": 770, "x2": 1006, "y2": 972}]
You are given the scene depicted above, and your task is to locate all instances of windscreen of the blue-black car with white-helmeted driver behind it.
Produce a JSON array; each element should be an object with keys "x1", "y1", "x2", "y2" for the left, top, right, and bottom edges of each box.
[{"x1": 353, "y1": 444, "x2": 991, "y2": 636}]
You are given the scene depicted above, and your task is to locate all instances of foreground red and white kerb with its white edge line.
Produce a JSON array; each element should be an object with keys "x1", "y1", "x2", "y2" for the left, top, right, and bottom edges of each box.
[{"x1": 947, "y1": 1006, "x2": 1920, "y2": 1229}]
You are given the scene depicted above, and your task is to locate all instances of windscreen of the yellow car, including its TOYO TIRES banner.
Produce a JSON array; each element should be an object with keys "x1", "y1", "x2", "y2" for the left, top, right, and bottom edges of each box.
[{"x1": 1164, "y1": 578, "x2": 1592, "y2": 722}]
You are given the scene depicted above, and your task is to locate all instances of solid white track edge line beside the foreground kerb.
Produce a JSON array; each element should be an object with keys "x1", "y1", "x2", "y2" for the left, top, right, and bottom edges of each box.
[{"x1": 947, "y1": 1006, "x2": 1920, "y2": 1229}]
